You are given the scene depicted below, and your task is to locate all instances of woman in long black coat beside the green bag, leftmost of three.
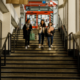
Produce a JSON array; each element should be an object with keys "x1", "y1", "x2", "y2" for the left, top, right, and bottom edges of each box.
[{"x1": 23, "y1": 19, "x2": 32, "y2": 49}]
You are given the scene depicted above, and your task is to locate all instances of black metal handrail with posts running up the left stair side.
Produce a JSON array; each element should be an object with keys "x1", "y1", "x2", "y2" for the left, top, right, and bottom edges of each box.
[{"x1": 0, "y1": 29, "x2": 19, "y2": 80}]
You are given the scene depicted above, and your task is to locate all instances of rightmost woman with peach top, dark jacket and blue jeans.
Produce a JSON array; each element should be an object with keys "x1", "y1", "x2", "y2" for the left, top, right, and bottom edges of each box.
[{"x1": 47, "y1": 22, "x2": 55, "y2": 50}]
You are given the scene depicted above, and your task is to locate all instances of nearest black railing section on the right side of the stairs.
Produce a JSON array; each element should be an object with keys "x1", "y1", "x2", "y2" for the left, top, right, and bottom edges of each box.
[{"x1": 68, "y1": 32, "x2": 80, "y2": 72}]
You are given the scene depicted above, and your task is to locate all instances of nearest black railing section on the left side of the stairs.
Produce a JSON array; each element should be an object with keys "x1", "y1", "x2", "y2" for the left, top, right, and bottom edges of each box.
[{"x1": 0, "y1": 33, "x2": 11, "y2": 80}]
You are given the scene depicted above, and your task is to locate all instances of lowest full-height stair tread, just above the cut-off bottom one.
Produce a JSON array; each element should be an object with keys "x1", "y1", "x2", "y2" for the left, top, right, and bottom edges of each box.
[{"x1": 1, "y1": 73, "x2": 80, "y2": 78}]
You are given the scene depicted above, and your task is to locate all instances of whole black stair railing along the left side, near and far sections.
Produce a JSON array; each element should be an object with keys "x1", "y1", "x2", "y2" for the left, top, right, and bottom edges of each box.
[{"x1": 0, "y1": 28, "x2": 20, "y2": 80}]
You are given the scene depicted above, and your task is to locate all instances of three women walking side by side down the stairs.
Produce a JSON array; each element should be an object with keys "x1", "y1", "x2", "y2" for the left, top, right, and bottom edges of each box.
[{"x1": 23, "y1": 19, "x2": 55, "y2": 50}]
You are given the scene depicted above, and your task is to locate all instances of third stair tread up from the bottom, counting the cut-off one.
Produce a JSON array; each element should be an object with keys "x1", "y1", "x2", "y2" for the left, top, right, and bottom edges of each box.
[{"x1": 1, "y1": 69, "x2": 77, "y2": 73}]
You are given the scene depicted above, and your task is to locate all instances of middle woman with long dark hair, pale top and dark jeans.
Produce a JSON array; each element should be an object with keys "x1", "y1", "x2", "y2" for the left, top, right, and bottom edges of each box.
[{"x1": 38, "y1": 20, "x2": 46, "y2": 48}]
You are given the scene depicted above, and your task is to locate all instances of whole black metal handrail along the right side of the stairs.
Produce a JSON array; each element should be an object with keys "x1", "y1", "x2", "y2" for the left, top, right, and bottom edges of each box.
[{"x1": 61, "y1": 27, "x2": 80, "y2": 72}]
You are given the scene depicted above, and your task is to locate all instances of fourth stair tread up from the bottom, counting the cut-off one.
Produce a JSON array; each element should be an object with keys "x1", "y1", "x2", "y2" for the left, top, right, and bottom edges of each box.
[{"x1": 2, "y1": 64, "x2": 77, "y2": 69}]
